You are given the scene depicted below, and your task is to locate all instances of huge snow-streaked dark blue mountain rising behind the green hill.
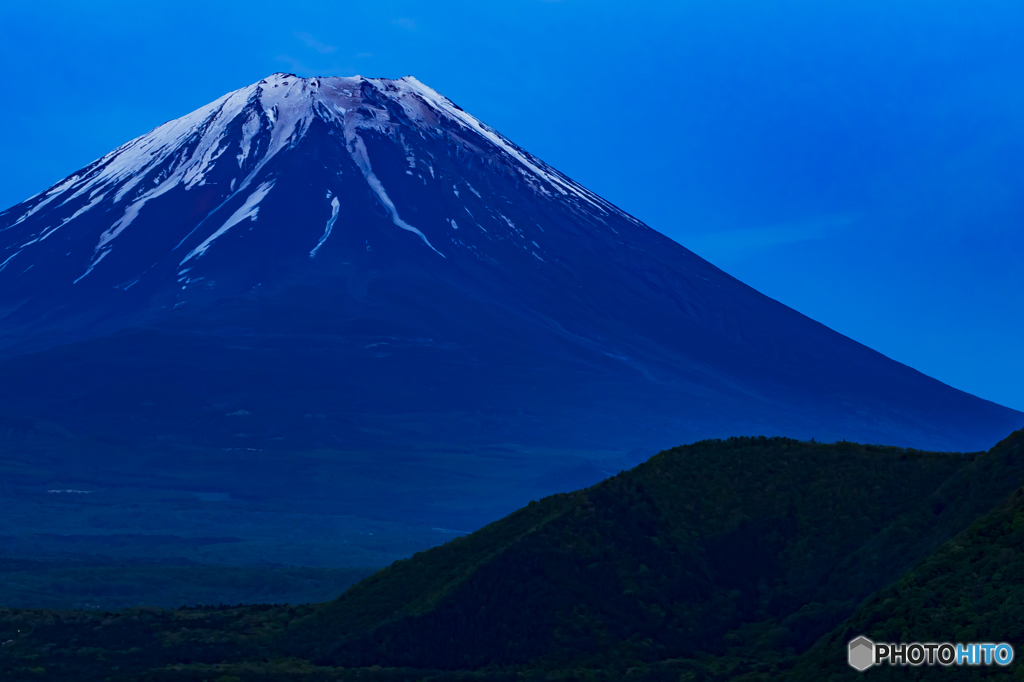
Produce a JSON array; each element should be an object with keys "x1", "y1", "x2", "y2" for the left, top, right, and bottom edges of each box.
[{"x1": 0, "y1": 74, "x2": 1024, "y2": 518}]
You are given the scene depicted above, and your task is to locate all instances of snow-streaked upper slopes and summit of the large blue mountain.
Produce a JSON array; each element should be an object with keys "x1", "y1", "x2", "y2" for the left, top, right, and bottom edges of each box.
[{"x1": 0, "y1": 74, "x2": 610, "y2": 303}]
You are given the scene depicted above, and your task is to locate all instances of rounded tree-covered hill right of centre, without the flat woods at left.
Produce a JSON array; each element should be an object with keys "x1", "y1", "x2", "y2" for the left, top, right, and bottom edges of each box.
[{"x1": 297, "y1": 438, "x2": 969, "y2": 670}]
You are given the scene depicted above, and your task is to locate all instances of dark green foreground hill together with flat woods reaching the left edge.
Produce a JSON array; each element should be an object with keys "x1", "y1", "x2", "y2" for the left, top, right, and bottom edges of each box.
[{"x1": 0, "y1": 432, "x2": 1024, "y2": 680}]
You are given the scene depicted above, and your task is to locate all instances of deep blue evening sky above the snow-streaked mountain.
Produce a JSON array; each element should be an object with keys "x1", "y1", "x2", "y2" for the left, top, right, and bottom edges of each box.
[{"x1": 0, "y1": 0, "x2": 1024, "y2": 410}]
